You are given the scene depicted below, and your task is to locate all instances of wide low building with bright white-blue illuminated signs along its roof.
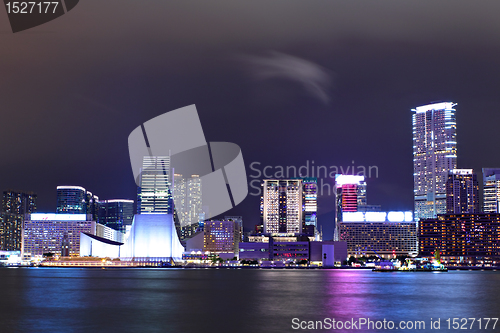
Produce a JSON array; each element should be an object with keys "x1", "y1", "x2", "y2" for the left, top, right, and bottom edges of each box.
[{"x1": 339, "y1": 211, "x2": 418, "y2": 258}]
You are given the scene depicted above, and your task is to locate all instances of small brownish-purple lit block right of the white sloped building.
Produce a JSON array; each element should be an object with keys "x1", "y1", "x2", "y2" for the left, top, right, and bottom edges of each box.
[{"x1": 203, "y1": 221, "x2": 241, "y2": 256}]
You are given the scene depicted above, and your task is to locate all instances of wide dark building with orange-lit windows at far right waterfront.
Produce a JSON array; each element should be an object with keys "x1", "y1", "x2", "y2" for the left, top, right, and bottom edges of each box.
[{"x1": 419, "y1": 213, "x2": 500, "y2": 264}]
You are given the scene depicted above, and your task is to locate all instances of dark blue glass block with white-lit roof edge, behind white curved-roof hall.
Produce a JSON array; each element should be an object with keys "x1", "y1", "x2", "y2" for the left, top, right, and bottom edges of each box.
[{"x1": 97, "y1": 199, "x2": 134, "y2": 232}]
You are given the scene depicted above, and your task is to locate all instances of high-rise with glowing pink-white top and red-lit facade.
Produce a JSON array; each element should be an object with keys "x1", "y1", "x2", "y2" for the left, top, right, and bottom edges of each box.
[{"x1": 333, "y1": 174, "x2": 366, "y2": 241}]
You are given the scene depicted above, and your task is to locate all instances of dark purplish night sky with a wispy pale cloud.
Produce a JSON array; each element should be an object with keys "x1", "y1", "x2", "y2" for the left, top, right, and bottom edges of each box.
[{"x1": 0, "y1": 0, "x2": 500, "y2": 239}]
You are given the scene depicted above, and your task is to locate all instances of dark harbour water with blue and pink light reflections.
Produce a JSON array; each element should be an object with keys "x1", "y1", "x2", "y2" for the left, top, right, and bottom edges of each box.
[{"x1": 0, "y1": 268, "x2": 500, "y2": 333}]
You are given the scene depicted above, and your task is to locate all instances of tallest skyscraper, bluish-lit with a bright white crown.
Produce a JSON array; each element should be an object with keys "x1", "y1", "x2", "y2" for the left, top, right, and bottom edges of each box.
[{"x1": 412, "y1": 102, "x2": 457, "y2": 221}]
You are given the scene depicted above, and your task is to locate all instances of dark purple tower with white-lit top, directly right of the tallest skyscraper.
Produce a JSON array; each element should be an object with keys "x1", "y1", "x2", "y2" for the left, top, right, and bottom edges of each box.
[{"x1": 446, "y1": 169, "x2": 480, "y2": 214}]
